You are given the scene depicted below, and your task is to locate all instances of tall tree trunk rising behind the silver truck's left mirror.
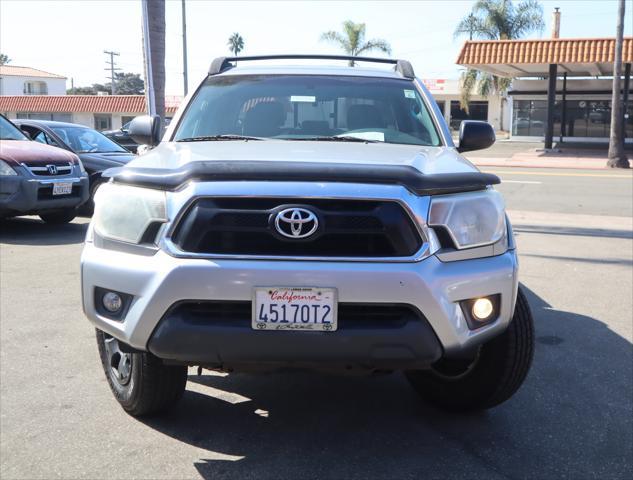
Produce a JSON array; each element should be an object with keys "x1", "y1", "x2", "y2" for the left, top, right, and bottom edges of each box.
[{"x1": 143, "y1": 0, "x2": 165, "y2": 124}]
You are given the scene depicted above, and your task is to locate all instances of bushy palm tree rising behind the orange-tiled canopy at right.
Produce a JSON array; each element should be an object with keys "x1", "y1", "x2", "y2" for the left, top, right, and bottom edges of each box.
[{"x1": 454, "y1": 0, "x2": 545, "y2": 115}]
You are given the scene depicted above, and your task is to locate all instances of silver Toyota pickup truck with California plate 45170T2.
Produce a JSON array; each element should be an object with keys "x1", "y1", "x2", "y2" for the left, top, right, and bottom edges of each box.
[{"x1": 81, "y1": 56, "x2": 533, "y2": 415}]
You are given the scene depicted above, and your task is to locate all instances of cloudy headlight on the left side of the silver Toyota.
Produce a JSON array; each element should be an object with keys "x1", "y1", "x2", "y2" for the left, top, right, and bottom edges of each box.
[{"x1": 92, "y1": 183, "x2": 167, "y2": 244}]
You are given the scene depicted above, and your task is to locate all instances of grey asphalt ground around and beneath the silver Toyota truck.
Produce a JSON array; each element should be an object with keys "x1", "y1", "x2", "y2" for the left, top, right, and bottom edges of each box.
[{"x1": 0, "y1": 169, "x2": 633, "y2": 479}]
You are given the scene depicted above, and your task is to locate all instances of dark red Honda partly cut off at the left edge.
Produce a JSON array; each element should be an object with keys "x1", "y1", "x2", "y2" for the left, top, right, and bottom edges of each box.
[{"x1": 0, "y1": 115, "x2": 89, "y2": 223}]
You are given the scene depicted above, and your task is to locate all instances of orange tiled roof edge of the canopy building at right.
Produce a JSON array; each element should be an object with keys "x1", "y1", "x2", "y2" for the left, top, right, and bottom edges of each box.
[{"x1": 456, "y1": 37, "x2": 633, "y2": 65}]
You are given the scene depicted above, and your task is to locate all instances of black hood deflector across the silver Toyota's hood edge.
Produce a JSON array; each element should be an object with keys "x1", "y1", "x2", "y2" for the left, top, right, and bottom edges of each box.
[{"x1": 103, "y1": 160, "x2": 501, "y2": 195}]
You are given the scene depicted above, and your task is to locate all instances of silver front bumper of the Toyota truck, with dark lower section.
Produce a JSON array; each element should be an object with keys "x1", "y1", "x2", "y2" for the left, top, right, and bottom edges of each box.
[{"x1": 81, "y1": 243, "x2": 518, "y2": 368}]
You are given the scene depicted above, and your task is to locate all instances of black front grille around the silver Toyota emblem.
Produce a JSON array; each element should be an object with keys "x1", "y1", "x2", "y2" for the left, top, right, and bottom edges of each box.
[{"x1": 172, "y1": 197, "x2": 423, "y2": 258}]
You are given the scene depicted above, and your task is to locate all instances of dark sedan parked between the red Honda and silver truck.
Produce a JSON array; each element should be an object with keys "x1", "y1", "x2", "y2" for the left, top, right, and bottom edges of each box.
[{"x1": 14, "y1": 119, "x2": 135, "y2": 211}]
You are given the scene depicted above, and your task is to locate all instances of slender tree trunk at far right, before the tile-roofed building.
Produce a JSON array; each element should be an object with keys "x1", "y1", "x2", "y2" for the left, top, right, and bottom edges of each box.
[{"x1": 607, "y1": 0, "x2": 629, "y2": 168}]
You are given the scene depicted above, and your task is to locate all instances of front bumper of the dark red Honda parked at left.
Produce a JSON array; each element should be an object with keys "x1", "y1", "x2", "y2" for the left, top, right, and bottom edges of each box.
[{"x1": 0, "y1": 166, "x2": 90, "y2": 215}]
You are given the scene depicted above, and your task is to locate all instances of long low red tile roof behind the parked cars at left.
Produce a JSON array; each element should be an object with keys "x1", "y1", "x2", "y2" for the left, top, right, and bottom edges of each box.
[{"x1": 0, "y1": 95, "x2": 180, "y2": 114}]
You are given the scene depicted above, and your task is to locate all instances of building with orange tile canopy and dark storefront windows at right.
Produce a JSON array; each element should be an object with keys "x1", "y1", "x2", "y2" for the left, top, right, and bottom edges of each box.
[{"x1": 456, "y1": 37, "x2": 633, "y2": 144}]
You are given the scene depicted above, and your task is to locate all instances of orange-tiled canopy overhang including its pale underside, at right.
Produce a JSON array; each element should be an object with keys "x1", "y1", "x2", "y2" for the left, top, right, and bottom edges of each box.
[{"x1": 456, "y1": 37, "x2": 633, "y2": 78}]
